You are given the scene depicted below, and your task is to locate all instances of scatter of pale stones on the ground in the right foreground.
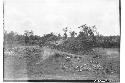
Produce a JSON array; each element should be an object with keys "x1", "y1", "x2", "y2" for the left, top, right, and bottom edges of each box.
[{"x1": 61, "y1": 55, "x2": 103, "y2": 72}]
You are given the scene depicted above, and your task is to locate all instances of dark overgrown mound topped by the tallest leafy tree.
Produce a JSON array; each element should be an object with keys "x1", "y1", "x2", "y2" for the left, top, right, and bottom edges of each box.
[{"x1": 63, "y1": 24, "x2": 96, "y2": 53}]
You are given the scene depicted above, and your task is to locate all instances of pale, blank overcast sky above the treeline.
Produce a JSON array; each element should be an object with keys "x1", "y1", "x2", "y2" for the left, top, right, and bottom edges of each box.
[{"x1": 4, "y1": 0, "x2": 120, "y2": 36}]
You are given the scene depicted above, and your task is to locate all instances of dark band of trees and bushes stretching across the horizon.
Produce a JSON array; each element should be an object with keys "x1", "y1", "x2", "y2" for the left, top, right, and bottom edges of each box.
[{"x1": 4, "y1": 24, "x2": 120, "y2": 51}]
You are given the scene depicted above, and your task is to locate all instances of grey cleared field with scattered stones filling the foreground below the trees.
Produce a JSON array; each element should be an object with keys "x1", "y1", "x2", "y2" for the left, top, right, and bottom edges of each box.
[{"x1": 4, "y1": 46, "x2": 120, "y2": 81}]
